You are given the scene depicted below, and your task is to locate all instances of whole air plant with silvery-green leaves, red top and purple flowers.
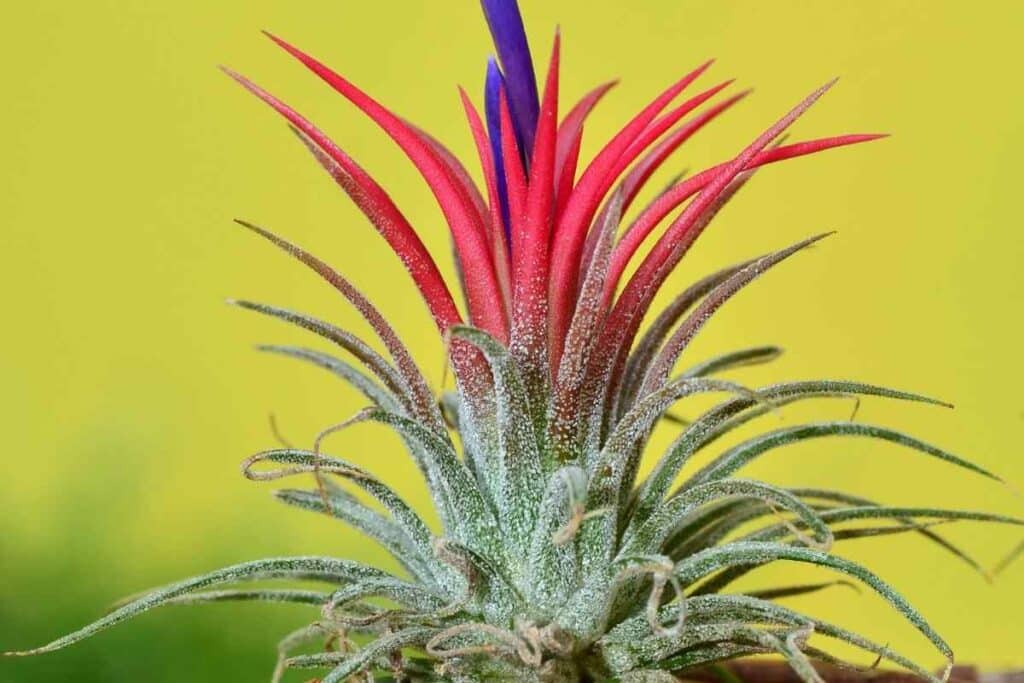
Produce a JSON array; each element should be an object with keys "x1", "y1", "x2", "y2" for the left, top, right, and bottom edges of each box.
[{"x1": 8, "y1": 0, "x2": 1020, "y2": 683}]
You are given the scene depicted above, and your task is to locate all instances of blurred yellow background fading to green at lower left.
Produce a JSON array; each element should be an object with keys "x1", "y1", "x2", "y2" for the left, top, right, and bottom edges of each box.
[{"x1": 0, "y1": 0, "x2": 1024, "y2": 683}]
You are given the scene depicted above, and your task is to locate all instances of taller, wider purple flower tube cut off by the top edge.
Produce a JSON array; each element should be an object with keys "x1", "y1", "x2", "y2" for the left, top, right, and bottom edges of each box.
[{"x1": 480, "y1": 0, "x2": 541, "y2": 158}]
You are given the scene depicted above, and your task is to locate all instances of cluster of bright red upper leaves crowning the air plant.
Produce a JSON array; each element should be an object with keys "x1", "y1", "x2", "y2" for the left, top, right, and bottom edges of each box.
[{"x1": 222, "y1": 18, "x2": 880, "y2": 423}]
